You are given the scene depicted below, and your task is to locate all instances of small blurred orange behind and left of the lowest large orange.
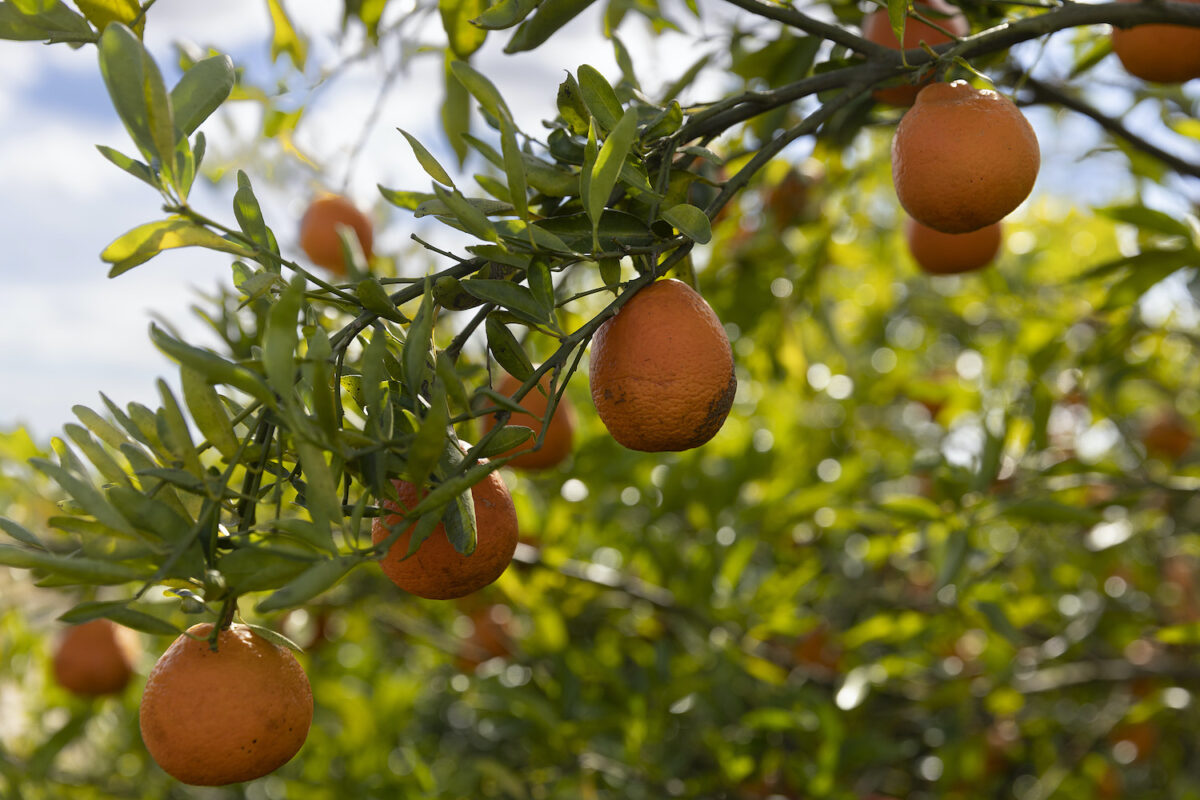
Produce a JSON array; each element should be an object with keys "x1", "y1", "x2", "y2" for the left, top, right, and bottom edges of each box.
[{"x1": 53, "y1": 619, "x2": 139, "y2": 697}]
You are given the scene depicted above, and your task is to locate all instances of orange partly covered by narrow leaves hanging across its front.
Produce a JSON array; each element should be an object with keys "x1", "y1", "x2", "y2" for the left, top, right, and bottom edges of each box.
[{"x1": 371, "y1": 473, "x2": 518, "y2": 600}]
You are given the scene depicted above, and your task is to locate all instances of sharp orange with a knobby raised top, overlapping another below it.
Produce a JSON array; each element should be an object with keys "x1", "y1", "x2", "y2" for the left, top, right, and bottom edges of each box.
[{"x1": 892, "y1": 80, "x2": 1042, "y2": 234}]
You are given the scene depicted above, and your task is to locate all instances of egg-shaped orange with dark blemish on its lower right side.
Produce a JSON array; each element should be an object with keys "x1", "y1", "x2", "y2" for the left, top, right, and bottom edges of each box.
[{"x1": 589, "y1": 278, "x2": 738, "y2": 452}]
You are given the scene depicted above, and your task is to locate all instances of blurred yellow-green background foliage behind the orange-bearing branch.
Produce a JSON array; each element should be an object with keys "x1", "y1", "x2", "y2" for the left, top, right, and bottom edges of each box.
[{"x1": 0, "y1": 2, "x2": 1200, "y2": 800}]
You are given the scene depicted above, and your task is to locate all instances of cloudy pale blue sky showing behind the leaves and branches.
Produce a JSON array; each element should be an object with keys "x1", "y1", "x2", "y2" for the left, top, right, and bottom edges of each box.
[{"x1": 0, "y1": 0, "x2": 1200, "y2": 438}]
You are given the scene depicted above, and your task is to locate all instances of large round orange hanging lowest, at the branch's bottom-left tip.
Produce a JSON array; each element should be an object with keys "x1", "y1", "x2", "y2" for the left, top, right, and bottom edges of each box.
[{"x1": 139, "y1": 622, "x2": 312, "y2": 786}]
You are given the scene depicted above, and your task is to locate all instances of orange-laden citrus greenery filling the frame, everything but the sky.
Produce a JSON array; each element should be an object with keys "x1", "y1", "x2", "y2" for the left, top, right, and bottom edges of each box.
[{"x1": 0, "y1": 0, "x2": 1200, "y2": 799}]
